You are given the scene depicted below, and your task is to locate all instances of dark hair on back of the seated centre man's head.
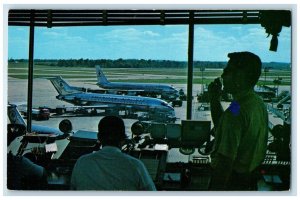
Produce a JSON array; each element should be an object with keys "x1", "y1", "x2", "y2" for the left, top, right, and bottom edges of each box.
[{"x1": 98, "y1": 116, "x2": 127, "y2": 146}]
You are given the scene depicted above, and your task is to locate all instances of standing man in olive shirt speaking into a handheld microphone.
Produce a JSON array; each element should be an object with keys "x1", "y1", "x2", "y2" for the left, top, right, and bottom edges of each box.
[{"x1": 208, "y1": 52, "x2": 268, "y2": 190}]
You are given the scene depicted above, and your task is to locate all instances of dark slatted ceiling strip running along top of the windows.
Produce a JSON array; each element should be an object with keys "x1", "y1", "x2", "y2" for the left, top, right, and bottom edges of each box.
[{"x1": 8, "y1": 9, "x2": 261, "y2": 28}]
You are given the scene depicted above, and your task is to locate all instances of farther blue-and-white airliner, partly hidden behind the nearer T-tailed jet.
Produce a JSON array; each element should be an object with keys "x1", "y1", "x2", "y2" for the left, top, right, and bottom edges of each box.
[{"x1": 96, "y1": 65, "x2": 179, "y2": 101}]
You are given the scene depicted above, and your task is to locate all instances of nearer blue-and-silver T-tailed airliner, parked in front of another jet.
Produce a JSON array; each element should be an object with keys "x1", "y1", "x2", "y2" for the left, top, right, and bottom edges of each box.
[{"x1": 49, "y1": 77, "x2": 176, "y2": 121}]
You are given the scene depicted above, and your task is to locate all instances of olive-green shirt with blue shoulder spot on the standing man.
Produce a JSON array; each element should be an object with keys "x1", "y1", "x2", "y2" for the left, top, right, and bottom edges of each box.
[{"x1": 211, "y1": 91, "x2": 268, "y2": 173}]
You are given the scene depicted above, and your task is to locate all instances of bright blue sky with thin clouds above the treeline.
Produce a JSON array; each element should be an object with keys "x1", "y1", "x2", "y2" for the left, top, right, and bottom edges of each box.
[{"x1": 7, "y1": 25, "x2": 291, "y2": 63}]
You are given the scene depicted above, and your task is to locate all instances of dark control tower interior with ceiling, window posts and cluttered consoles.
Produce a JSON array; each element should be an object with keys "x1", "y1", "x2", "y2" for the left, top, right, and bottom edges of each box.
[{"x1": 7, "y1": 9, "x2": 292, "y2": 191}]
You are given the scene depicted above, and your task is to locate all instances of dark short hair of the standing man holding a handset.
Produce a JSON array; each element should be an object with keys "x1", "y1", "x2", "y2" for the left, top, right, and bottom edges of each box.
[{"x1": 228, "y1": 51, "x2": 262, "y2": 87}]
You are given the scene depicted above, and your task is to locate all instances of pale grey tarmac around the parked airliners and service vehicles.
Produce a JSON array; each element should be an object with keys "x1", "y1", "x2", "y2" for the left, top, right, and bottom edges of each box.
[{"x1": 7, "y1": 77, "x2": 287, "y2": 162}]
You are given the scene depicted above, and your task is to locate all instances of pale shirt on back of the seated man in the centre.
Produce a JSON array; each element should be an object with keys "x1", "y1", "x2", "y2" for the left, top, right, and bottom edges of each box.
[{"x1": 71, "y1": 146, "x2": 156, "y2": 191}]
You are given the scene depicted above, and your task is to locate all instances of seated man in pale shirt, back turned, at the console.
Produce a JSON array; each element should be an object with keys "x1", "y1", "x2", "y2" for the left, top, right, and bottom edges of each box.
[{"x1": 71, "y1": 116, "x2": 156, "y2": 191}]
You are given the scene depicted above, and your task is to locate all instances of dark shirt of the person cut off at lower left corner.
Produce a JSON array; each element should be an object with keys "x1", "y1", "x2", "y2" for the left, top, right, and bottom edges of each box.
[{"x1": 7, "y1": 154, "x2": 45, "y2": 190}]
